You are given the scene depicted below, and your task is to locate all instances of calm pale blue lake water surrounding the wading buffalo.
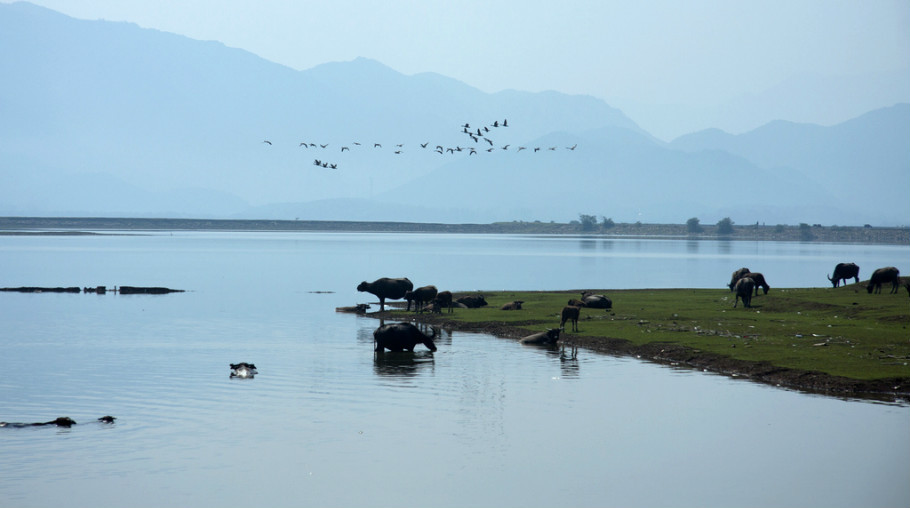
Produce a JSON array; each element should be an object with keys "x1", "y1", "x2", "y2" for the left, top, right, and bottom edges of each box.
[{"x1": 0, "y1": 232, "x2": 910, "y2": 507}]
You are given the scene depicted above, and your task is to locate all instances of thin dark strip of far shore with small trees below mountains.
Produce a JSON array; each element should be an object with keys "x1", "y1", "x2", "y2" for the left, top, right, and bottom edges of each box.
[{"x1": 0, "y1": 217, "x2": 910, "y2": 245}]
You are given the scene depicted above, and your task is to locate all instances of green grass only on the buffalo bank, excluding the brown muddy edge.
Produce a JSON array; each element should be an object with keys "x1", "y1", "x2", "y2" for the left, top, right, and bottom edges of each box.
[{"x1": 392, "y1": 285, "x2": 910, "y2": 380}]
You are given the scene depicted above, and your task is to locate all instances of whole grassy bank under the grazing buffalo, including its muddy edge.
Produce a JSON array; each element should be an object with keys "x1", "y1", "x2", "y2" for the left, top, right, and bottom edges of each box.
[{"x1": 386, "y1": 284, "x2": 910, "y2": 398}]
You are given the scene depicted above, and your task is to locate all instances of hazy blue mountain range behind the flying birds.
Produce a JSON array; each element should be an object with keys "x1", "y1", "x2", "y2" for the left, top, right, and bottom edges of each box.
[{"x1": 0, "y1": 2, "x2": 910, "y2": 225}]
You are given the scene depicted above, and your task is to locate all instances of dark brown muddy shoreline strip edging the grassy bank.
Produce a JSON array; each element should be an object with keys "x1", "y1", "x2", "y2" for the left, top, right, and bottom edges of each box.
[{"x1": 363, "y1": 311, "x2": 910, "y2": 403}]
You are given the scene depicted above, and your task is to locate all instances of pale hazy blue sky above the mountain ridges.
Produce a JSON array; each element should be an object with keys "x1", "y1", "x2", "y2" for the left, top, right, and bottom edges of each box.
[{"x1": 14, "y1": 0, "x2": 910, "y2": 141}]
